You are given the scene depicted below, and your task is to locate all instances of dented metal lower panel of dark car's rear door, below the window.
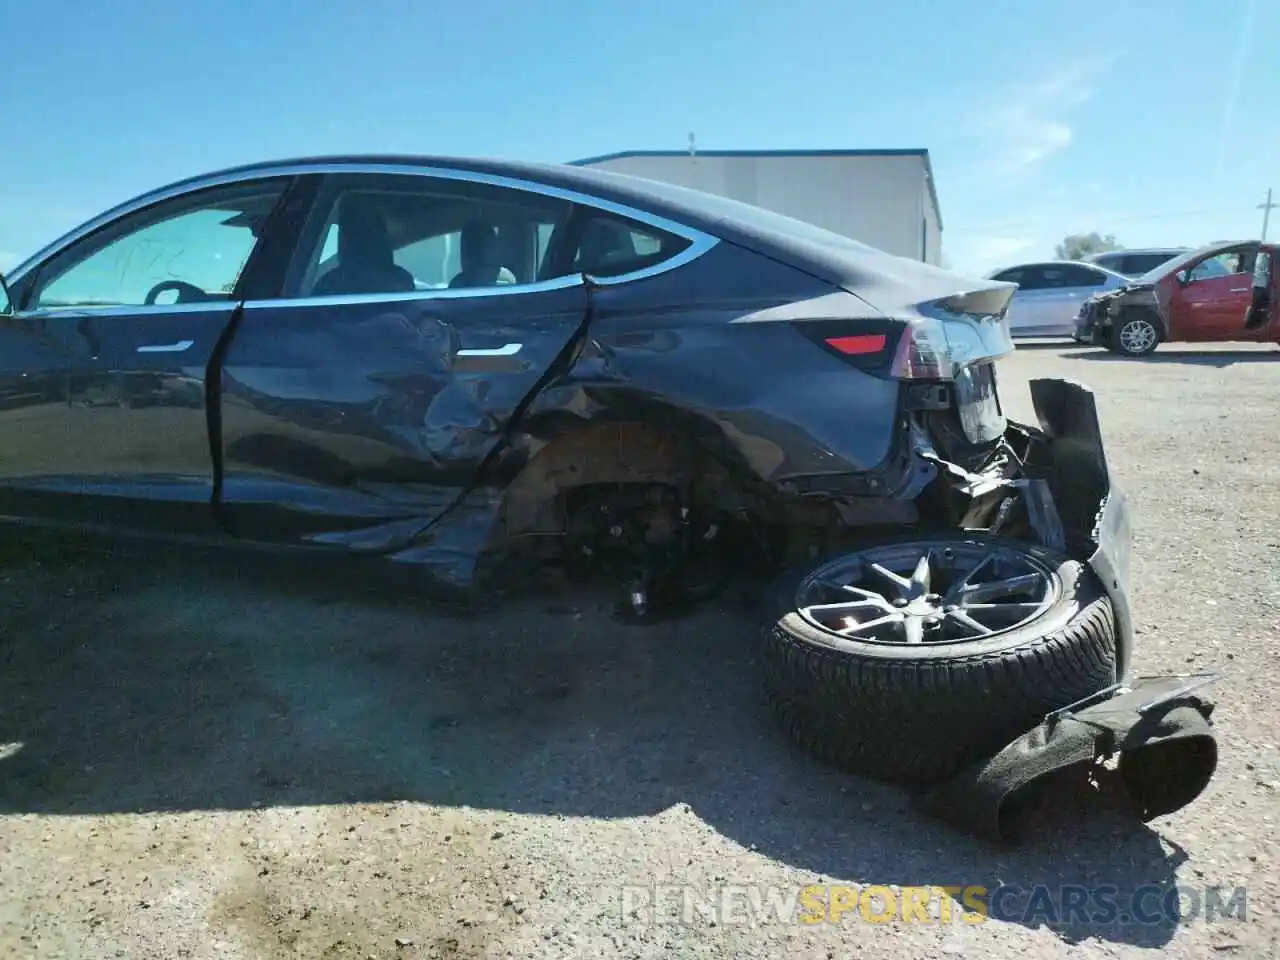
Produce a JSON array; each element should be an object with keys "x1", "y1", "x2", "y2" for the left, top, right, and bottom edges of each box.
[{"x1": 220, "y1": 287, "x2": 586, "y2": 552}]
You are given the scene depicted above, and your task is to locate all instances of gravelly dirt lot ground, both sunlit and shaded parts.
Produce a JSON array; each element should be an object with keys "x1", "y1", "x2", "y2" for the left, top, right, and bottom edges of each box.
[{"x1": 0, "y1": 344, "x2": 1280, "y2": 960}]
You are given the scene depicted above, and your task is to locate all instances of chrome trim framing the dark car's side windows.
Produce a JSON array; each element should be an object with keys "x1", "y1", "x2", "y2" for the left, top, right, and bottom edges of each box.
[{"x1": 6, "y1": 163, "x2": 721, "y2": 300}]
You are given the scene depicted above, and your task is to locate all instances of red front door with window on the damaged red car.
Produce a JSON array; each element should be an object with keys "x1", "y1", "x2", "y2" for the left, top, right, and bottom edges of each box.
[{"x1": 1158, "y1": 243, "x2": 1258, "y2": 342}]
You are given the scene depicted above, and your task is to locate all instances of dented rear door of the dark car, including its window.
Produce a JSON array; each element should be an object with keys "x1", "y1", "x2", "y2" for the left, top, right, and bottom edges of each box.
[{"x1": 219, "y1": 173, "x2": 634, "y2": 552}]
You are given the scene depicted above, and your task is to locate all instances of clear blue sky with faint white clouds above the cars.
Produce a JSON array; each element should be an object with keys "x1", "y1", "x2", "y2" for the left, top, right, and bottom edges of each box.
[{"x1": 0, "y1": 0, "x2": 1280, "y2": 273}]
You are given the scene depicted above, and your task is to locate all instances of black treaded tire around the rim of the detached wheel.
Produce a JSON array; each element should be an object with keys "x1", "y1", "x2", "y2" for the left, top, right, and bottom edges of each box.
[{"x1": 763, "y1": 536, "x2": 1116, "y2": 786}]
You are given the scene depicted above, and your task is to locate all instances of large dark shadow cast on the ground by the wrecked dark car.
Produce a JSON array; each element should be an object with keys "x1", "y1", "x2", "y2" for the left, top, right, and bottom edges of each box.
[{"x1": 0, "y1": 545, "x2": 1180, "y2": 947}]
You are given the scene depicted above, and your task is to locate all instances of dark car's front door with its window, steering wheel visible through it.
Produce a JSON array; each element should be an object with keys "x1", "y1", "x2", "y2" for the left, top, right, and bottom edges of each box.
[{"x1": 0, "y1": 178, "x2": 291, "y2": 532}]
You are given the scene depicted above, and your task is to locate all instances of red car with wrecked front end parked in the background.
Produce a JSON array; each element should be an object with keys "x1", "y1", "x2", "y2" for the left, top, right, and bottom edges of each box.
[{"x1": 1075, "y1": 241, "x2": 1280, "y2": 357}]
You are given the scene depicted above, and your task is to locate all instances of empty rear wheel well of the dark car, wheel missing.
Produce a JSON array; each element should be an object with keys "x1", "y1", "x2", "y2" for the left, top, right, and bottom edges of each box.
[{"x1": 489, "y1": 421, "x2": 936, "y2": 593}]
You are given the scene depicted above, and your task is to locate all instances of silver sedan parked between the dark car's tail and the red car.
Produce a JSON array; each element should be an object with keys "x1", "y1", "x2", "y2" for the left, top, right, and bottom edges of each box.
[{"x1": 987, "y1": 260, "x2": 1129, "y2": 338}]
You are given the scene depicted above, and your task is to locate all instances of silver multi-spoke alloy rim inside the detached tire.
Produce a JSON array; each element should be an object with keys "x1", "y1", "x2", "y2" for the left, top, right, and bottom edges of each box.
[{"x1": 796, "y1": 540, "x2": 1061, "y2": 645}]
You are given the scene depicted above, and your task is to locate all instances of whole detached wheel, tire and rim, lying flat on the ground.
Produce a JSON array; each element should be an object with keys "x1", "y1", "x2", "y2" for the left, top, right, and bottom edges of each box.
[{"x1": 764, "y1": 536, "x2": 1116, "y2": 785}]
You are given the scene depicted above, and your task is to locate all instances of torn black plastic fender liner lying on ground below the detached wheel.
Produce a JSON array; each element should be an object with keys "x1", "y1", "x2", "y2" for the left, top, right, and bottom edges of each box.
[{"x1": 918, "y1": 677, "x2": 1217, "y2": 842}]
